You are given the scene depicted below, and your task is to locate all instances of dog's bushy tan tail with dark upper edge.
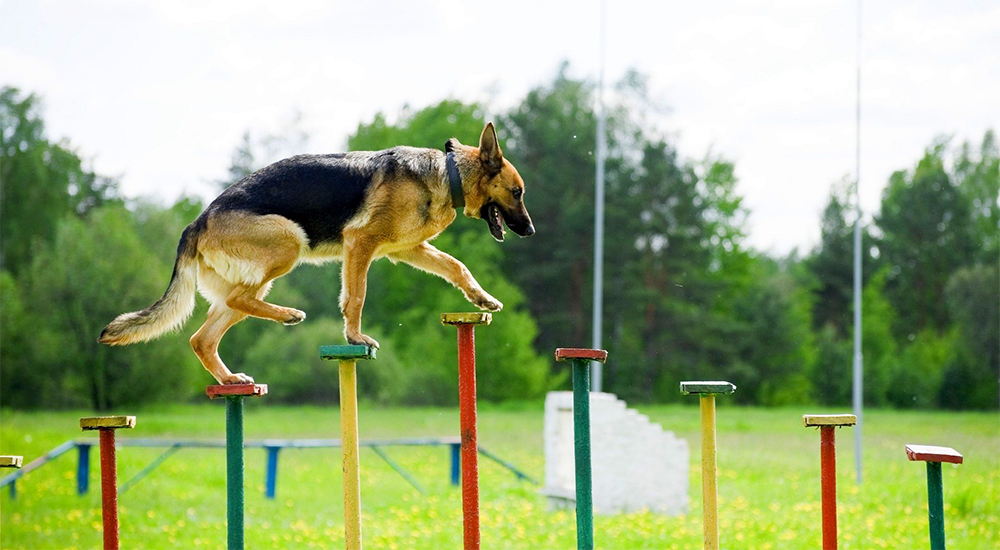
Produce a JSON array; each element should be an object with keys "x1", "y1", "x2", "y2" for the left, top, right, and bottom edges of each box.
[{"x1": 97, "y1": 220, "x2": 202, "y2": 346}]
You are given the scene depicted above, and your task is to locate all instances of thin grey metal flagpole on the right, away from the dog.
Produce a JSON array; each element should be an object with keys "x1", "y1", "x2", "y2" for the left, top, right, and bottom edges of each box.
[{"x1": 853, "y1": 0, "x2": 864, "y2": 485}]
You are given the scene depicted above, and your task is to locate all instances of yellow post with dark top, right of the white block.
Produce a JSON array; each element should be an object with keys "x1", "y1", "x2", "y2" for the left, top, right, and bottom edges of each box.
[{"x1": 681, "y1": 381, "x2": 736, "y2": 550}]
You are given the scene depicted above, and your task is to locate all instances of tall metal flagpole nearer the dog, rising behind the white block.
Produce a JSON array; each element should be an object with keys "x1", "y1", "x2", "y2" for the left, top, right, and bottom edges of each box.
[{"x1": 591, "y1": 0, "x2": 607, "y2": 392}]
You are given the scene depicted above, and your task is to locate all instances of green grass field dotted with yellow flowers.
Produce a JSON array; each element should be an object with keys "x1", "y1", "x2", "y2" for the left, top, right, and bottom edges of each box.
[{"x1": 0, "y1": 400, "x2": 1000, "y2": 550}]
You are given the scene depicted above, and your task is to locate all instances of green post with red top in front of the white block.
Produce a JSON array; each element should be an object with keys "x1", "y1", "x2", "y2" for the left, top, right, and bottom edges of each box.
[{"x1": 556, "y1": 348, "x2": 608, "y2": 550}]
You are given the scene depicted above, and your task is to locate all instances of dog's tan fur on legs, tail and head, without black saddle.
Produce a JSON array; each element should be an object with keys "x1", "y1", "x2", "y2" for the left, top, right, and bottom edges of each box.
[{"x1": 100, "y1": 123, "x2": 534, "y2": 384}]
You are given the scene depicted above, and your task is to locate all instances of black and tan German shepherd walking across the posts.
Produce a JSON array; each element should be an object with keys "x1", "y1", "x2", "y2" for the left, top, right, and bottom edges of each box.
[{"x1": 99, "y1": 123, "x2": 535, "y2": 384}]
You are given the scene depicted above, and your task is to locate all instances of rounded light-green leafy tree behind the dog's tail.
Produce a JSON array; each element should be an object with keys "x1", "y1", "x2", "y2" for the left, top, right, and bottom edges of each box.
[{"x1": 13, "y1": 206, "x2": 200, "y2": 410}]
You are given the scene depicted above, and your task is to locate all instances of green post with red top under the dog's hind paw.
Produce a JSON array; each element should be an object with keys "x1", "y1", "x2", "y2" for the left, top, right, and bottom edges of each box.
[{"x1": 205, "y1": 384, "x2": 267, "y2": 550}]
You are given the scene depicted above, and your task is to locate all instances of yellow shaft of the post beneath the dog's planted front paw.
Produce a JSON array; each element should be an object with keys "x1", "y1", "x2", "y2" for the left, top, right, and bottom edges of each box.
[{"x1": 340, "y1": 360, "x2": 361, "y2": 550}]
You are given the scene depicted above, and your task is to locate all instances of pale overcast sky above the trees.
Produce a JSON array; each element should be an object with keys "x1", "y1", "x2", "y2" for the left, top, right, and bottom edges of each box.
[{"x1": 0, "y1": 0, "x2": 1000, "y2": 254}]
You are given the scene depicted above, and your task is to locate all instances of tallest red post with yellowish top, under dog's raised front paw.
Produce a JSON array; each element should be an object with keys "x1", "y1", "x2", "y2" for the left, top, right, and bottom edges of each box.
[{"x1": 441, "y1": 313, "x2": 493, "y2": 550}]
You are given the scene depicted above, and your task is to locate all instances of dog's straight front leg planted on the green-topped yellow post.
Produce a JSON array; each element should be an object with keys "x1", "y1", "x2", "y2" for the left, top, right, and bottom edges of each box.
[{"x1": 340, "y1": 235, "x2": 378, "y2": 348}]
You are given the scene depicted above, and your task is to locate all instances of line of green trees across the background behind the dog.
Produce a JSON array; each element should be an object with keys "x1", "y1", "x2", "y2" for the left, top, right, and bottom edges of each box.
[{"x1": 0, "y1": 72, "x2": 1000, "y2": 409}]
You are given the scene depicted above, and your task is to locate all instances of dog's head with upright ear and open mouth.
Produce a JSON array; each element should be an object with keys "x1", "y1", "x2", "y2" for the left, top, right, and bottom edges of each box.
[{"x1": 446, "y1": 122, "x2": 535, "y2": 241}]
